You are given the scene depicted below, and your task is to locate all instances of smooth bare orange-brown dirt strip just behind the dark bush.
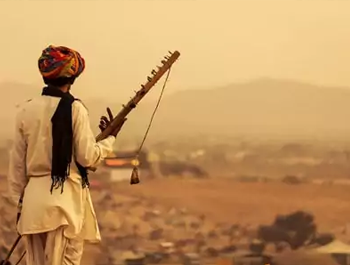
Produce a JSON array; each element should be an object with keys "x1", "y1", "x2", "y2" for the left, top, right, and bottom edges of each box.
[{"x1": 109, "y1": 179, "x2": 350, "y2": 231}]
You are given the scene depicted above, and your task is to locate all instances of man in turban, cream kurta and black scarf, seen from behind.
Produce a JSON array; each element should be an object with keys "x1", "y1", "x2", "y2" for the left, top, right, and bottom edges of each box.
[{"x1": 8, "y1": 46, "x2": 126, "y2": 265}]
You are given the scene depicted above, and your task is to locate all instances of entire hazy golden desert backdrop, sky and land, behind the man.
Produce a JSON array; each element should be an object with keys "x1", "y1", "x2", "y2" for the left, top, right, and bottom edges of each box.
[{"x1": 0, "y1": 0, "x2": 350, "y2": 265}]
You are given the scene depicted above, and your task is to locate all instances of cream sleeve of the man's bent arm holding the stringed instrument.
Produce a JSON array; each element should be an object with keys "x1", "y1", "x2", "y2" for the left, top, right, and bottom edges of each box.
[{"x1": 72, "y1": 100, "x2": 115, "y2": 168}]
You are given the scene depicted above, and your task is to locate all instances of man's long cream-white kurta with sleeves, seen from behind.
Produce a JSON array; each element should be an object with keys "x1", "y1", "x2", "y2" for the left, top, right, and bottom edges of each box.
[{"x1": 8, "y1": 96, "x2": 115, "y2": 242}]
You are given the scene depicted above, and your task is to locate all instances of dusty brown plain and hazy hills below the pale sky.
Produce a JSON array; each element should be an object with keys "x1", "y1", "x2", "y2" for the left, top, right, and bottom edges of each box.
[{"x1": 0, "y1": 79, "x2": 350, "y2": 265}]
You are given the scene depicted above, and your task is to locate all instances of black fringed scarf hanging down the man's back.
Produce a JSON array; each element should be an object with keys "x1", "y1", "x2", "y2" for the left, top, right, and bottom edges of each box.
[{"x1": 41, "y1": 86, "x2": 89, "y2": 193}]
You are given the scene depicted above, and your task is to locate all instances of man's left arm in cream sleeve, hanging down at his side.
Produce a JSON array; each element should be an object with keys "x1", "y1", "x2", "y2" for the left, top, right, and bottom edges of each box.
[{"x1": 7, "y1": 108, "x2": 28, "y2": 204}]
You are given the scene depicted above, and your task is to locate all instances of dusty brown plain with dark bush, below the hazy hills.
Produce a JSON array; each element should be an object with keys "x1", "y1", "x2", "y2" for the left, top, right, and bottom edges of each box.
[{"x1": 0, "y1": 96, "x2": 350, "y2": 265}]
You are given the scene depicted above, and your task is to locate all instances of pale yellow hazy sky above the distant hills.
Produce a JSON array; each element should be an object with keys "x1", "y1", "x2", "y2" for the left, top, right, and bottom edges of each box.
[{"x1": 0, "y1": 0, "x2": 350, "y2": 98}]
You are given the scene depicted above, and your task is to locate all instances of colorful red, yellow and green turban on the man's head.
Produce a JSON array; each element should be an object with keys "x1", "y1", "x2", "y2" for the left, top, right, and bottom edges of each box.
[{"x1": 38, "y1": 45, "x2": 85, "y2": 79}]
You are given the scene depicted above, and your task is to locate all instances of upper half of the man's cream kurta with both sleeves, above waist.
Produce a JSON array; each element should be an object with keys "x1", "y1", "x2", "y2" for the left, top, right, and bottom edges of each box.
[{"x1": 8, "y1": 93, "x2": 115, "y2": 202}]
